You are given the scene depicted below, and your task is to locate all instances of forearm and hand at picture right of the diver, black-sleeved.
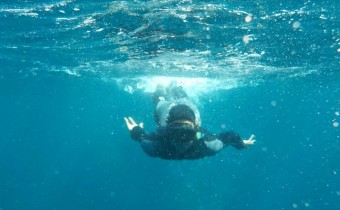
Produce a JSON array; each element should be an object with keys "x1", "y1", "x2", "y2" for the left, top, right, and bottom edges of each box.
[{"x1": 219, "y1": 131, "x2": 255, "y2": 149}]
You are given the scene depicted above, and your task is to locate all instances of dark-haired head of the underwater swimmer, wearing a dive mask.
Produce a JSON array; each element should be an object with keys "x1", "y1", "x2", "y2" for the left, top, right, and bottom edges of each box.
[{"x1": 167, "y1": 104, "x2": 197, "y2": 145}]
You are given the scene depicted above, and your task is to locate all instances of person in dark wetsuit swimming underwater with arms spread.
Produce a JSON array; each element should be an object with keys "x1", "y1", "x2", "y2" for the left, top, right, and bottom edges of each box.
[{"x1": 124, "y1": 84, "x2": 255, "y2": 160}]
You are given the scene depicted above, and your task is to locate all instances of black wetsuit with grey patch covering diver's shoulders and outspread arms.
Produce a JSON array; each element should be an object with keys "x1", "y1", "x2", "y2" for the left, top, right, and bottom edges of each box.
[{"x1": 131, "y1": 126, "x2": 245, "y2": 160}]
